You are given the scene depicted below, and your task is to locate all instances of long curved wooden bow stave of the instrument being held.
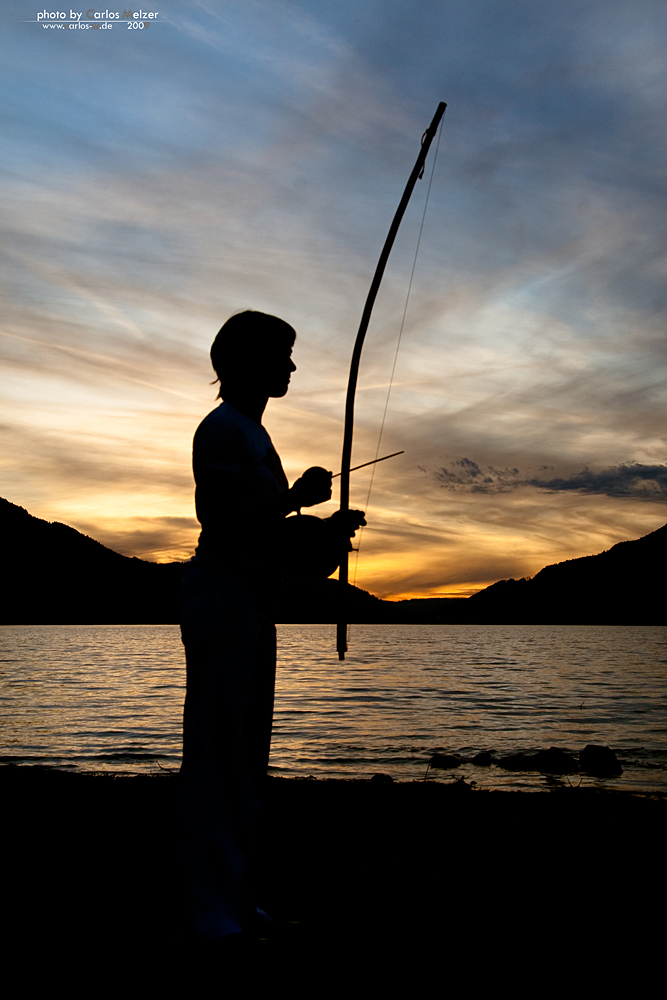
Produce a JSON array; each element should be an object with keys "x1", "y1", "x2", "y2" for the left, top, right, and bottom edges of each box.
[{"x1": 336, "y1": 102, "x2": 447, "y2": 660}]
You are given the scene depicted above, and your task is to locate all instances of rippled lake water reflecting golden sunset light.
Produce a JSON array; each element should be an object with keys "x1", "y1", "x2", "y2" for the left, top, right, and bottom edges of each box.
[{"x1": 0, "y1": 625, "x2": 667, "y2": 790}]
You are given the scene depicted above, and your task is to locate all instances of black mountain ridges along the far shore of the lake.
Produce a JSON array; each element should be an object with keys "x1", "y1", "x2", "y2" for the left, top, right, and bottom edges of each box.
[{"x1": 0, "y1": 498, "x2": 667, "y2": 625}]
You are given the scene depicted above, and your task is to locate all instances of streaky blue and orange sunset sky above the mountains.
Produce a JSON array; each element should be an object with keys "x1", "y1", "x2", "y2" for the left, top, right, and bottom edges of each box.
[{"x1": 0, "y1": 0, "x2": 667, "y2": 598}]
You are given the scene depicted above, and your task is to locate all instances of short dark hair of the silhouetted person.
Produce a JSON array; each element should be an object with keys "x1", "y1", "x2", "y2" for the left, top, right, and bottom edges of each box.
[{"x1": 211, "y1": 309, "x2": 296, "y2": 399}]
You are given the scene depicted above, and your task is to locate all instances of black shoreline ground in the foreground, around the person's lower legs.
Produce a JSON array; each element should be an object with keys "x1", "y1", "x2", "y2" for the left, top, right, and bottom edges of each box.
[{"x1": 0, "y1": 767, "x2": 667, "y2": 995}]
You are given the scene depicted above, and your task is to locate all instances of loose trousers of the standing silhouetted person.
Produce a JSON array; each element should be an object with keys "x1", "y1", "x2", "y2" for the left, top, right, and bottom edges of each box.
[{"x1": 180, "y1": 566, "x2": 276, "y2": 940}]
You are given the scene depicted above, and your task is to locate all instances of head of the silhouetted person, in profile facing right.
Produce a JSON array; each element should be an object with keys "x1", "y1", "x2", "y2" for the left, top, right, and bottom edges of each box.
[{"x1": 211, "y1": 309, "x2": 296, "y2": 399}]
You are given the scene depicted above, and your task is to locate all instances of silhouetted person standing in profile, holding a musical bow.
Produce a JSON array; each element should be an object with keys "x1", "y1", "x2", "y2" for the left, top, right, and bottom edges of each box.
[{"x1": 181, "y1": 312, "x2": 365, "y2": 941}]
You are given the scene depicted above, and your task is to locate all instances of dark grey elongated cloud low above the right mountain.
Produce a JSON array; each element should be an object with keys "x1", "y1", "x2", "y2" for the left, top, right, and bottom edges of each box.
[{"x1": 428, "y1": 458, "x2": 667, "y2": 502}]
